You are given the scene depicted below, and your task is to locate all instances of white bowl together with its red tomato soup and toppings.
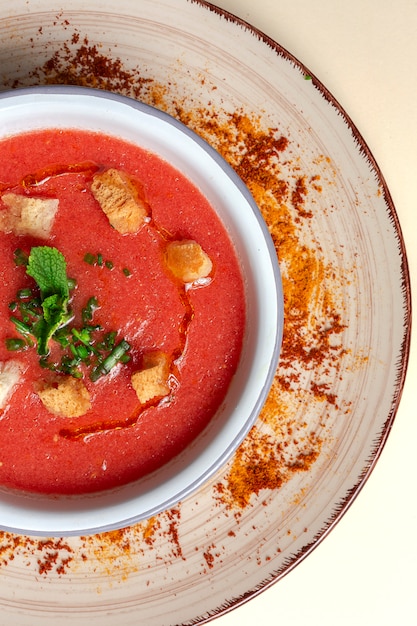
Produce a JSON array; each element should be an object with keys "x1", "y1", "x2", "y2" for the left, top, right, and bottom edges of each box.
[{"x1": 0, "y1": 86, "x2": 283, "y2": 536}]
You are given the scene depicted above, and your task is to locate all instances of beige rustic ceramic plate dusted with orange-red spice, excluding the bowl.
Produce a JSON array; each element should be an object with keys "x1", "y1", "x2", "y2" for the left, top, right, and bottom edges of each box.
[{"x1": 0, "y1": 0, "x2": 410, "y2": 626}]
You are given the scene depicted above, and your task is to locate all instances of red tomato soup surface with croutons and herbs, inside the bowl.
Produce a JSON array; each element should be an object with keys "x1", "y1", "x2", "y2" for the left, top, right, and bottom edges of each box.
[{"x1": 0, "y1": 129, "x2": 245, "y2": 494}]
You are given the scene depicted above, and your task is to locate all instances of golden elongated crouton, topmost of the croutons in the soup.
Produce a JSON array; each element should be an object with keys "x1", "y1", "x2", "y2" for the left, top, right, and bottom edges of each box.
[{"x1": 91, "y1": 169, "x2": 148, "y2": 235}]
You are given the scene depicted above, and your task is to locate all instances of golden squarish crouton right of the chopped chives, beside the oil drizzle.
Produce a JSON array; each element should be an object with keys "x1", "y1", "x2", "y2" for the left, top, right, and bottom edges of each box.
[{"x1": 132, "y1": 351, "x2": 170, "y2": 404}]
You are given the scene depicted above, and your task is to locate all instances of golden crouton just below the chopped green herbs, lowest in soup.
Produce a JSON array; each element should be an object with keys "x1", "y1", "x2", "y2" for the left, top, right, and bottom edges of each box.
[{"x1": 36, "y1": 376, "x2": 91, "y2": 417}]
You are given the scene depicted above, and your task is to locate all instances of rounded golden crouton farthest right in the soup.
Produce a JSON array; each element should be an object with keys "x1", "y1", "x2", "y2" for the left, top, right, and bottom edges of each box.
[{"x1": 165, "y1": 239, "x2": 213, "y2": 283}]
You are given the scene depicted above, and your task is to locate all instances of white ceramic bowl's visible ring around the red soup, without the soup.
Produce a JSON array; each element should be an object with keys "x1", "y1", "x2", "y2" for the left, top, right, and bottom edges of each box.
[{"x1": 0, "y1": 86, "x2": 283, "y2": 536}]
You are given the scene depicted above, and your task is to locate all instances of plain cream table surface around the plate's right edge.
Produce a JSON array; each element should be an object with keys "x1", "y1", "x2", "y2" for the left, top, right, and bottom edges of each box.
[{"x1": 215, "y1": 0, "x2": 417, "y2": 626}]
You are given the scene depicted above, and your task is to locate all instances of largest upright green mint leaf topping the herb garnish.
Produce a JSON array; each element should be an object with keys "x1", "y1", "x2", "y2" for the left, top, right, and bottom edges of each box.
[{"x1": 26, "y1": 246, "x2": 69, "y2": 300}]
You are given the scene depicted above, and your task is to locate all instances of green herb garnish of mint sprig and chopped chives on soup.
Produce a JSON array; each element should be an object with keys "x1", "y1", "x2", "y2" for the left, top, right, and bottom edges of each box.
[{"x1": 6, "y1": 246, "x2": 130, "y2": 381}]
